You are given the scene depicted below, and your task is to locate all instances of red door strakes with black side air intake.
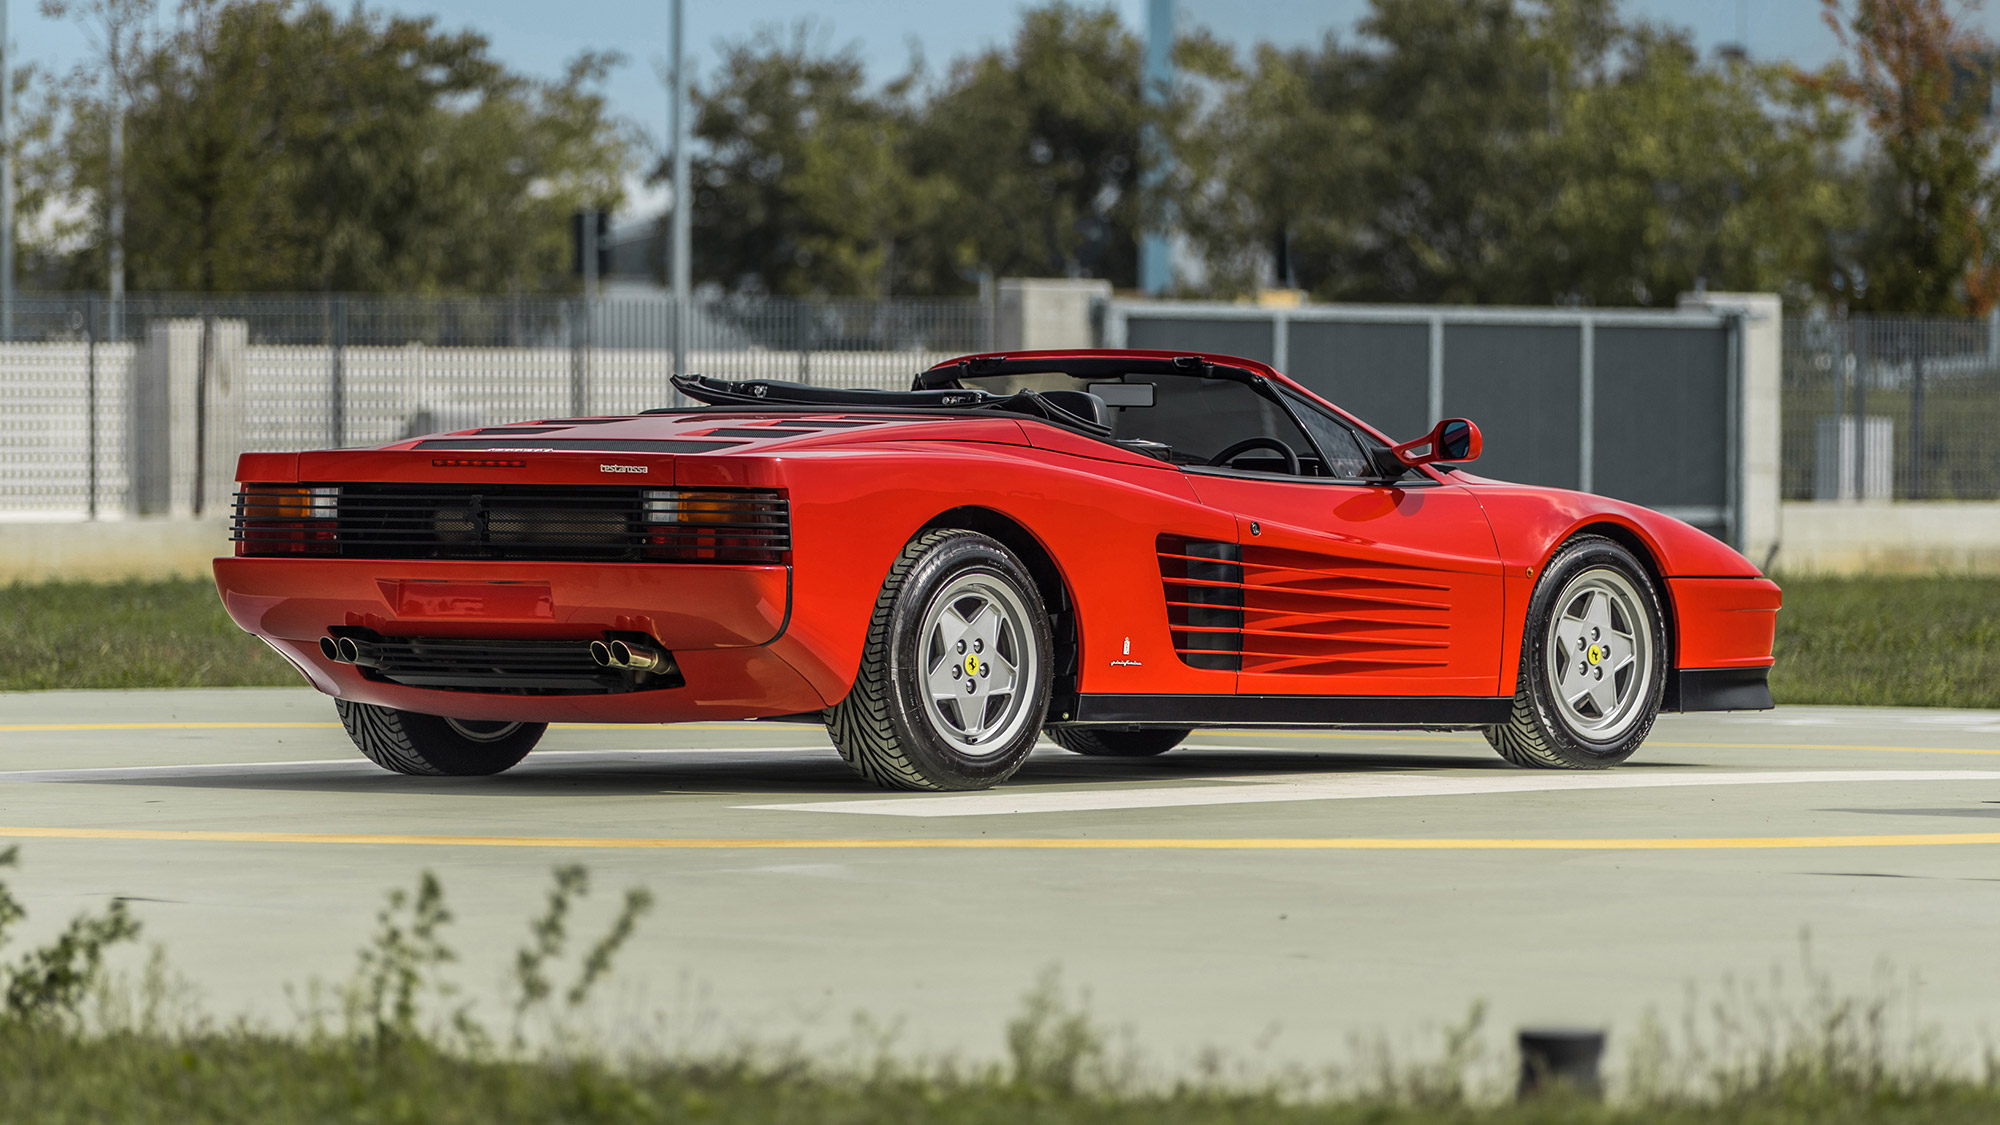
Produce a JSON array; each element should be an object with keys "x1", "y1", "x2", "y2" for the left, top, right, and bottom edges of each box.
[{"x1": 1160, "y1": 536, "x2": 1452, "y2": 675}]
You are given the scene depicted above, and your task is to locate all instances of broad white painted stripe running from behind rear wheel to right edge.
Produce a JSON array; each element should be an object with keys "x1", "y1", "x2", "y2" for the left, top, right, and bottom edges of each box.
[{"x1": 738, "y1": 769, "x2": 2000, "y2": 817}]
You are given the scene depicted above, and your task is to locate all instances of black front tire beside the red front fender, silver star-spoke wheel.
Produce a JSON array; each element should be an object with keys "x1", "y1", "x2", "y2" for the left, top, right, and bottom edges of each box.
[{"x1": 1486, "y1": 534, "x2": 1672, "y2": 769}]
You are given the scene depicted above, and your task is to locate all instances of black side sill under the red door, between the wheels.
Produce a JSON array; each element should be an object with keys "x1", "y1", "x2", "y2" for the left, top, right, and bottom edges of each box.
[{"x1": 1056, "y1": 695, "x2": 1514, "y2": 729}]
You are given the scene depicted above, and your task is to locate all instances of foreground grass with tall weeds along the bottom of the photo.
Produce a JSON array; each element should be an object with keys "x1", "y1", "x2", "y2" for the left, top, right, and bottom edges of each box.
[{"x1": 0, "y1": 849, "x2": 2000, "y2": 1125}]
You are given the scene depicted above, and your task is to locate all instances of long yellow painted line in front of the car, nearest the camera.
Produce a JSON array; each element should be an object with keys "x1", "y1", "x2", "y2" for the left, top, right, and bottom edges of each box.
[{"x1": 0, "y1": 827, "x2": 2000, "y2": 851}]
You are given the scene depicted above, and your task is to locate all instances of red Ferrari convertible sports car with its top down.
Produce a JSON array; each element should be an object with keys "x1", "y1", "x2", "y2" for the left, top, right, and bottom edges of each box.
[{"x1": 216, "y1": 350, "x2": 1780, "y2": 789}]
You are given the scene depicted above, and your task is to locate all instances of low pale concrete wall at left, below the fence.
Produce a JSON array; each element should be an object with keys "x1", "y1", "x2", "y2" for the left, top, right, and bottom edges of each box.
[{"x1": 0, "y1": 516, "x2": 232, "y2": 583}]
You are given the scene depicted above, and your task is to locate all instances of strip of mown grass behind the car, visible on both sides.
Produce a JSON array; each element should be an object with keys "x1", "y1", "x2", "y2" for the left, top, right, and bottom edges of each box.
[{"x1": 11, "y1": 577, "x2": 2000, "y2": 707}]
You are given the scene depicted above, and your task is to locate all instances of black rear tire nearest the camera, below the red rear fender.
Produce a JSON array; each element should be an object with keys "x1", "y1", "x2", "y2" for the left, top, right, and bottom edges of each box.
[{"x1": 826, "y1": 528, "x2": 1054, "y2": 791}]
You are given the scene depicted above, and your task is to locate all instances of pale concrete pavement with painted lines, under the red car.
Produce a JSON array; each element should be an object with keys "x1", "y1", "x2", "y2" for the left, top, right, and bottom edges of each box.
[{"x1": 0, "y1": 689, "x2": 2000, "y2": 1067}]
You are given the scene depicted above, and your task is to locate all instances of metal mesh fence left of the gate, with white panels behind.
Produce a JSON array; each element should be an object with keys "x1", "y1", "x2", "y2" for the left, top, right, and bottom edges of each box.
[{"x1": 0, "y1": 296, "x2": 992, "y2": 518}]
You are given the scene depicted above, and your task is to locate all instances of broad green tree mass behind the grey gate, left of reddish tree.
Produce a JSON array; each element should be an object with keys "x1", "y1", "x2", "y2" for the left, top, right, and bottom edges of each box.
[{"x1": 1178, "y1": 0, "x2": 1860, "y2": 304}]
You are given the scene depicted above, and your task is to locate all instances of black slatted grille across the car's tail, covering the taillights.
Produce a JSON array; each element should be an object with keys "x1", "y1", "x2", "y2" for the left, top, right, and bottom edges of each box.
[{"x1": 232, "y1": 482, "x2": 792, "y2": 565}]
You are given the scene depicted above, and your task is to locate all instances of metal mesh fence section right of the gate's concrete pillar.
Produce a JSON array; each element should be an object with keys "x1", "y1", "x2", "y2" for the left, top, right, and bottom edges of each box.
[{"x1": 1782, "y1": 308, "x2": 2000, "y2": 500}]
